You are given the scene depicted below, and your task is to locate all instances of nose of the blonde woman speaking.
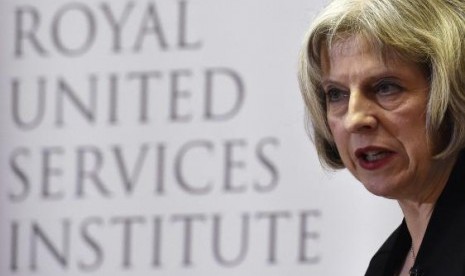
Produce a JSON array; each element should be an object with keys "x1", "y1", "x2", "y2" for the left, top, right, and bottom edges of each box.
[{"x1": 344, "y1": 91, "x2": 378, "y2": 133}]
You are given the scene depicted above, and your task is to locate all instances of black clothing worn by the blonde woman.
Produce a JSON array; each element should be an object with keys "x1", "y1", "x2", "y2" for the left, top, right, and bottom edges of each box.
[{"x1": 365, "y1": 152, "x2": 465, "y2": 276}]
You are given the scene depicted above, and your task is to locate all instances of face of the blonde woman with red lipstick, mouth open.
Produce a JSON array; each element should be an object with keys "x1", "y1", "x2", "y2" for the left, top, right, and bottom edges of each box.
[{"x1": 322, "y1": 37, "x2": 448, "y2": 199}]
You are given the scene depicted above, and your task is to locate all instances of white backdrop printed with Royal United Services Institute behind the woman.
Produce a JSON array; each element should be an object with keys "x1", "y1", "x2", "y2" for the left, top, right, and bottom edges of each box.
[{"x1": 0, "y1": 0, "x2": 401, "y2": 276}]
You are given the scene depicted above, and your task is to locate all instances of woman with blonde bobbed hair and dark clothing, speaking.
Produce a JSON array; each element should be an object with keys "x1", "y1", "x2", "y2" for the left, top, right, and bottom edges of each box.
[{"x1": 299, "y1": 0, "x2": 465, "y2": 276}]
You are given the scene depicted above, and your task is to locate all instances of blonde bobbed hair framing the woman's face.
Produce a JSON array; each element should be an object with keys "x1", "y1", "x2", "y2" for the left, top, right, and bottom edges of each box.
[{"x1": 299, "y1": 0, "x2": 465, "y2": 169}]
